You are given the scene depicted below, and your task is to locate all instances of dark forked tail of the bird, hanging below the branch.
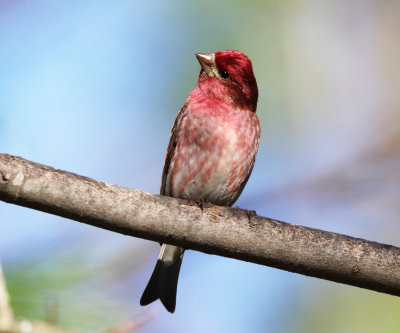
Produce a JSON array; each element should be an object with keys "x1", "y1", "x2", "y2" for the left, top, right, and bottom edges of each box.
[{"x1": 140, "y1": 244, "x2": 185, "y2": 313}]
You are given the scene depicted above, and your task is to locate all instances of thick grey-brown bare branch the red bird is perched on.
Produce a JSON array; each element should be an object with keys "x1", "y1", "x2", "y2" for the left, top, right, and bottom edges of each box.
[{"x1": 0, "y1": 154, "x2": 400, "y2": 296}]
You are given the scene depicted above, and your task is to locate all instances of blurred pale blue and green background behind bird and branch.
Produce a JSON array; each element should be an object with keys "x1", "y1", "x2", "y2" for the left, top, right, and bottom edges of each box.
[{"x1": 0, "y1": 0, "x2": 400, "y2": 333}]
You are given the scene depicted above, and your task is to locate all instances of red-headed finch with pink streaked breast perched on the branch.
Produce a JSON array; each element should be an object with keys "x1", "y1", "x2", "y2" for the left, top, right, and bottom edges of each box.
[{"x1": 140, "y1": 50, "x2": 261, "y2": 313}]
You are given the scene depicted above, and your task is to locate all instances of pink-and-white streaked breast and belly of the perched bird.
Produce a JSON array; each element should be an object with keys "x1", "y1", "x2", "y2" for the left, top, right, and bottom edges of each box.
[{"x1": 165, "y1": 110, "x2": 260, "y2": 206}]
